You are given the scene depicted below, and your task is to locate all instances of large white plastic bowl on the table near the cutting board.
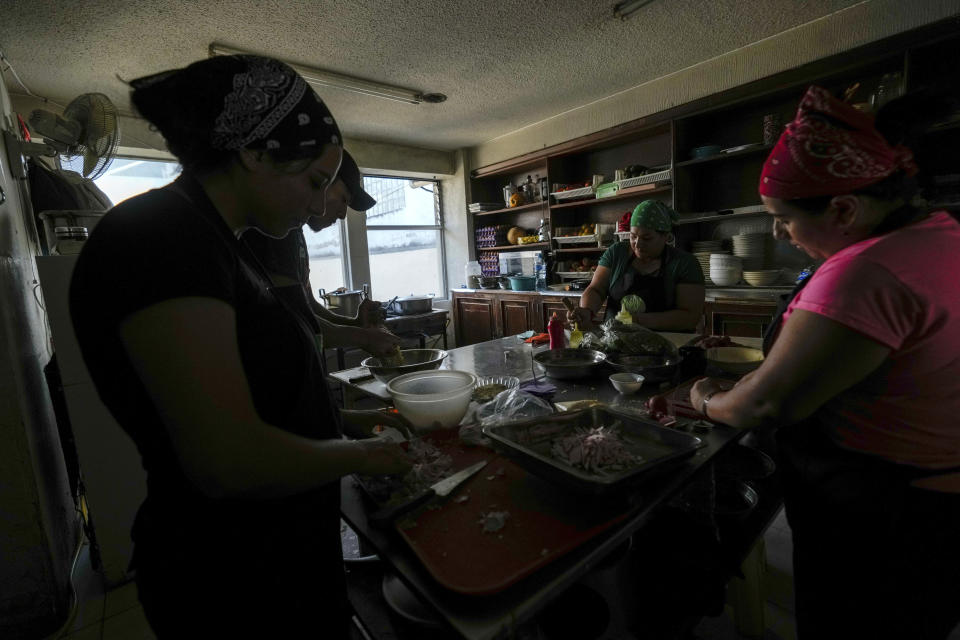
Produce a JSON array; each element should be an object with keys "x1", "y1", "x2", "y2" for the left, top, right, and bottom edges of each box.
[{"x1": 387, "y1": 370, "x2": 477, "y2": 431}]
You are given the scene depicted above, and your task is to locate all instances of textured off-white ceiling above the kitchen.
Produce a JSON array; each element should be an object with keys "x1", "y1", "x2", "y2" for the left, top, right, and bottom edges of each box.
[{"x1": 0, "y1": 0, "x2": 859, "y2": 150}]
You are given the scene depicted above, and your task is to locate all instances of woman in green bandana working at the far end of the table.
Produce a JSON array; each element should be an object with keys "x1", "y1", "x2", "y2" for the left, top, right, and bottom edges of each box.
[{"x1": 567, "y1": 200, "x2": 704, "y2": 331}]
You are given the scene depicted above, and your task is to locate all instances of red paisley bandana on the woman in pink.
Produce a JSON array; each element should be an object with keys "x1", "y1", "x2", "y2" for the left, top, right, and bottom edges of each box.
[{"x1": 760, "y1": 87, "x2": 917, "y2": 200}]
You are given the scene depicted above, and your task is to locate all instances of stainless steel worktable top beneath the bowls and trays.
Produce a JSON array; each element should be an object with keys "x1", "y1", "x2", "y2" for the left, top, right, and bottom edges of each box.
[{"x1": 332, "y1": 333, "x2": 760, "y2": 640}]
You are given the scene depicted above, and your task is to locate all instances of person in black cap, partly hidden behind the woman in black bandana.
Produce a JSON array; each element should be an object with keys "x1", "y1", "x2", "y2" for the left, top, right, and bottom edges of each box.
[{"x1": 241, "y1": 150, "x2": 400, "y2": 356}]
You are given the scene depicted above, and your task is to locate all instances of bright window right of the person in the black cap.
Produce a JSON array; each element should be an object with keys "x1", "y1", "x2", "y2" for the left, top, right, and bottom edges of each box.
[{"x1": 363, "y1": 176, "x2": 446, "y2": 300}]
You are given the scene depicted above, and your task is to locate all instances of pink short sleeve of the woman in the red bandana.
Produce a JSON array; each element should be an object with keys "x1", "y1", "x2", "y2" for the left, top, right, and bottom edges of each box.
[{"x1": 790, "y1": 256, "x2": 922, "y2": 349}]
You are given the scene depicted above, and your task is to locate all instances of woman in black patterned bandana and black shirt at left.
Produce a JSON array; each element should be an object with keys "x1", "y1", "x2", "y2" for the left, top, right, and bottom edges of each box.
[{"x1": 70, "y1": 56, "x2": 409, "y2": 638}]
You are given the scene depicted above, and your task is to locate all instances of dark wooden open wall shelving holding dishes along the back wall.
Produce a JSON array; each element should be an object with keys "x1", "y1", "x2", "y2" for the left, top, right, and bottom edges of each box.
[{"x1": 468, "y1": 22, "x2": 960, "y2": 290}]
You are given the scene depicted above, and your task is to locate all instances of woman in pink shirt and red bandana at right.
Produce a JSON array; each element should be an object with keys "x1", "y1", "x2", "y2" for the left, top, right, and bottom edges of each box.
[{"x1": 690, "y1": 87, "x2": 960, "y2": 639}]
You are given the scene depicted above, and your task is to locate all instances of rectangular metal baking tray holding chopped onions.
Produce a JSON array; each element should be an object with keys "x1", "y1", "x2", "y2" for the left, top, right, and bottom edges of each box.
[{"x1": 483, "y1": 407, "x2": 704, "y2": 494}]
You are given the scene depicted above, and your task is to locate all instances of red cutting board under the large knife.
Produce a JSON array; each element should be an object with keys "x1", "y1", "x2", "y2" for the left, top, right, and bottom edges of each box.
[{"x1": 396, "y1": 443, "x2": 628, "y2": 595}]
